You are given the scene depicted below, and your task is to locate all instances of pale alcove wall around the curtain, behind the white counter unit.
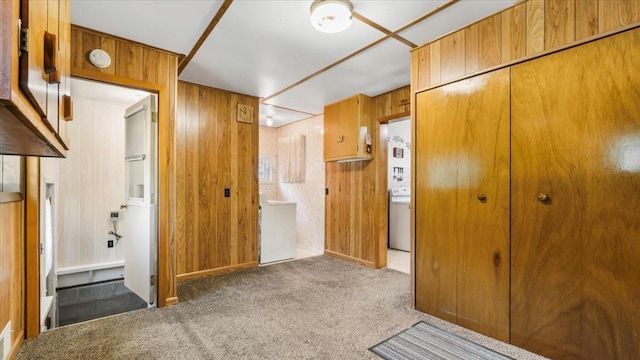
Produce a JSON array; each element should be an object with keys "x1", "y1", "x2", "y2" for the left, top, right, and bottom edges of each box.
[{"x1": 260, "y1": 115, "x2": 325, "y2": 254}]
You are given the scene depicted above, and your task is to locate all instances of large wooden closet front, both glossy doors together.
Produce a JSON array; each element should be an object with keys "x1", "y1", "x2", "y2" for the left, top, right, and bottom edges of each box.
[{"x1": 415, "y1": 28, "x2": 640, "y2": 359}]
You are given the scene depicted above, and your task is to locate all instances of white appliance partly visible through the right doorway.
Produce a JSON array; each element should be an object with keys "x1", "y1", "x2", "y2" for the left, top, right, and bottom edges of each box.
[{"x1": 389, "y1": 187, "x2": 411, "y2": 251}]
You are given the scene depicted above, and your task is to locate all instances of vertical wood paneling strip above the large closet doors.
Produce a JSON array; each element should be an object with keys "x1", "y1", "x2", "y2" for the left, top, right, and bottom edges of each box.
[{"x1": 411, "y1": 0, "x2": 640, "y2": 93}]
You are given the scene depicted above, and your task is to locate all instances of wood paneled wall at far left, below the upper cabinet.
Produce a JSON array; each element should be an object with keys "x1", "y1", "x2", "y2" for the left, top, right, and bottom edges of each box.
[{"x1": 0, "y1": 201, "x2": 25, "y2": 358}]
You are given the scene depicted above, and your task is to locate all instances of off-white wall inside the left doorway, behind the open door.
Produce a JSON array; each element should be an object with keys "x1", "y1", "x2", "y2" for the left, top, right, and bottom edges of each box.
[{"x1": 57, "y1": 97, "x2": 127, "y2": 268}]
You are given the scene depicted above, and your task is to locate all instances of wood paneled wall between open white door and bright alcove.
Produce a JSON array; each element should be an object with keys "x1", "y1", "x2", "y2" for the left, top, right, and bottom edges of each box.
[{"x1": 175, "y1": 81, "x2": 259, "y2": 280}]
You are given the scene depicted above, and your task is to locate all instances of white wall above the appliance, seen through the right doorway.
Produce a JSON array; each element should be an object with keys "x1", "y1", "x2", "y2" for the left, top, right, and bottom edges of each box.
[{"x1": 387, "y1": 119, "x2": 411, "y2": 188}]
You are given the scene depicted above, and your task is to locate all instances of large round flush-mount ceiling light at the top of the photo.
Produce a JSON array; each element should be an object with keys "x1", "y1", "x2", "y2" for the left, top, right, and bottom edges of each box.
[{"x1": 311, "y1": 0, "x2": 353, "y2": 33}]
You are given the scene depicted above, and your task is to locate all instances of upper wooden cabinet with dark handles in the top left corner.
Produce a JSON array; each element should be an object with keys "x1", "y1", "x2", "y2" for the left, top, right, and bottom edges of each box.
[{"x1": 0, "y1": 0, "x2": 72, "y2": 157}]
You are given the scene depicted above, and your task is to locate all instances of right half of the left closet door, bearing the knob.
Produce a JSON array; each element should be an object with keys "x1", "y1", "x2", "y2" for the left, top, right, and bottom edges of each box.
[{"x1": 456, "y1": 68, "x2": 510, "y2": 342}]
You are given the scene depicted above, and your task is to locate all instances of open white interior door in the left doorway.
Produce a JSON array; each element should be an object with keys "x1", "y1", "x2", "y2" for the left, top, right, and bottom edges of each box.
[{"x1": 121, "y1": 95, "x2": 158, "y2": 305}]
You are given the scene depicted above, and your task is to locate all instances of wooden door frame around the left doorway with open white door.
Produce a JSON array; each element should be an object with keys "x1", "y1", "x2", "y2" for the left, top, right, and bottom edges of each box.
[{"x1": 25, "y1": 72, "x2": 169, "y2": 339}]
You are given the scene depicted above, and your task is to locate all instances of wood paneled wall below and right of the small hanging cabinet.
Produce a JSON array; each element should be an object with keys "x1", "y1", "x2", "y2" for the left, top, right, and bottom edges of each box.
[{"x1": 325, "y1": 86, "x2": 410, "y2": 268}]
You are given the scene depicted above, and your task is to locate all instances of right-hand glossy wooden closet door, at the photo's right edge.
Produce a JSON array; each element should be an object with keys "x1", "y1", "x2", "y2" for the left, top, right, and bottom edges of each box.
[{"x1": 511, "y1": 29, "x2": 640, "y2": 359}]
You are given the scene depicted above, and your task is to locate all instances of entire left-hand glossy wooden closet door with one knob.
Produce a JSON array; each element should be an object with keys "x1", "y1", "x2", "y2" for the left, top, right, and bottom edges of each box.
[{"x1": 416, "y1": 69, "x2": 509, "y2": 341}]
